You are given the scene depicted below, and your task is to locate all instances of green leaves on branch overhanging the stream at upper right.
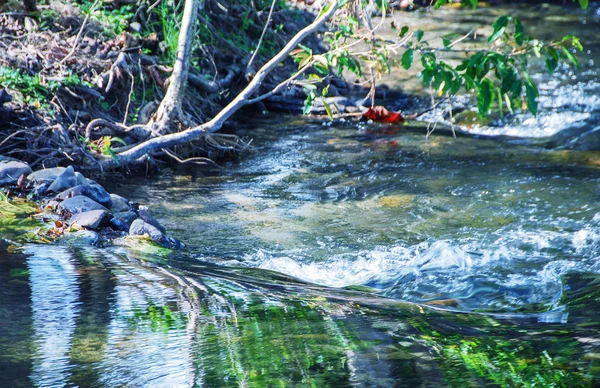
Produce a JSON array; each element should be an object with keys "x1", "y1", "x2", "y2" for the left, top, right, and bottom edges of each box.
[{"x1": 292, "y1": 0, "x2": 588, "y2": 117}]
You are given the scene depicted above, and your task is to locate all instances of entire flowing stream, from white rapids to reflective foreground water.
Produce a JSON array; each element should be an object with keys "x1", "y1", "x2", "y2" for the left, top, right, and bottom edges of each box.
[{"x1": 0, "y1": 4, "x2": 600, "y2": 387}]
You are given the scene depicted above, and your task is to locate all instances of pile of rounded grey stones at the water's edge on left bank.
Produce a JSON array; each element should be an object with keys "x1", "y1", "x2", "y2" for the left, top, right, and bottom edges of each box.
[{"x1": 0, "y1": 157, "x2": 182, "y2": 249}]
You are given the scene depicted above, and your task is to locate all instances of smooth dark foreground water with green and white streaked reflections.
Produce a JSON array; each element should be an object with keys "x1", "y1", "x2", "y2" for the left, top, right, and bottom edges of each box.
[{"x1": 0, "y1": 244, "x2": 600, "y2": 387}]
